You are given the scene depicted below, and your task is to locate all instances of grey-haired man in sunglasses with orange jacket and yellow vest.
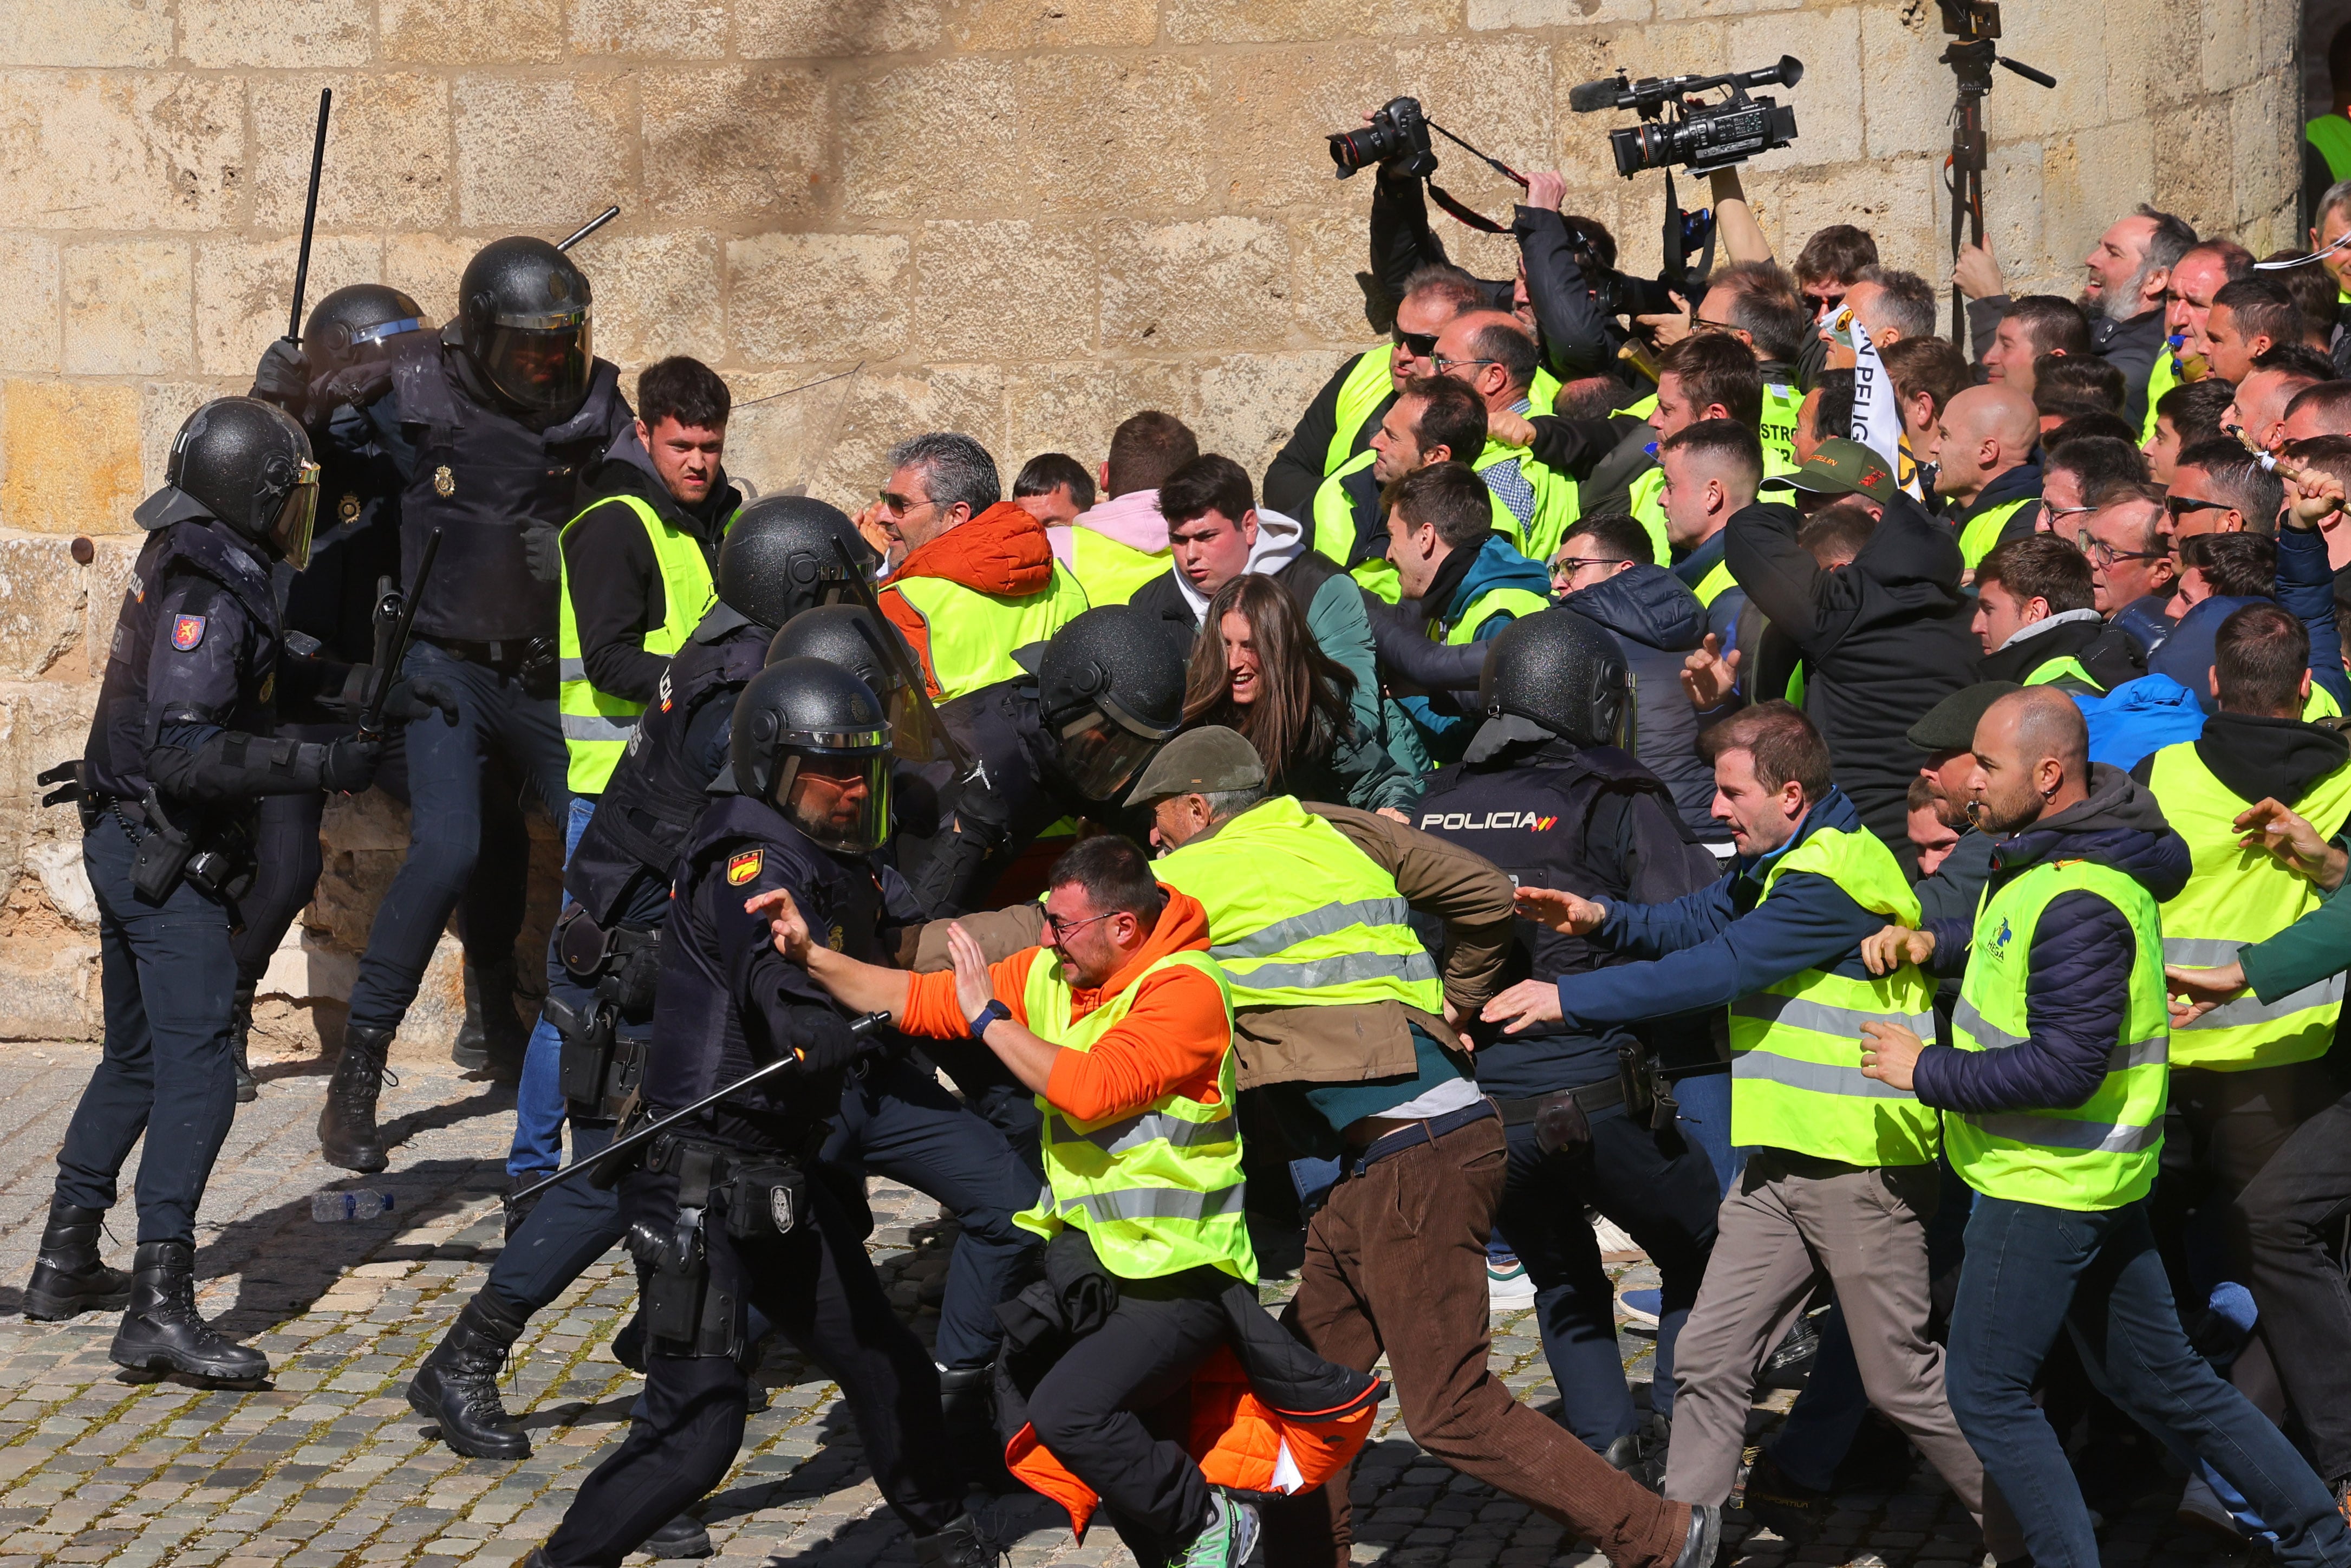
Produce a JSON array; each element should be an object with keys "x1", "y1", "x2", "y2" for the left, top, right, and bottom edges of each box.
[{"x1": 872, "y1": 430, "x2": 1086, "y2": 703}]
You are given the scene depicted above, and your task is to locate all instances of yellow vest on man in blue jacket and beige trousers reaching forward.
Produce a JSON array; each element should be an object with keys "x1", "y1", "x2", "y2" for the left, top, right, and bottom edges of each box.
[{"x1": 1730, "y1": 828, "x2": 1935, "y2": 1166}]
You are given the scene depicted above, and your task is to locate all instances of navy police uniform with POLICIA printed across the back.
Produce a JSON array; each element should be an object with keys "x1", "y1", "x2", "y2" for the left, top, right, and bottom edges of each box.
[{"x1": 1415, "y1": 740, "x2": 1728, "y2": 1448}]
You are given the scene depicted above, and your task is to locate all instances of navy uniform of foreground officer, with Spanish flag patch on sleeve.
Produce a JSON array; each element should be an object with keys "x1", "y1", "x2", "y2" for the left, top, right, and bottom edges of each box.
[{"x1": 545, "y1": 797, "x2": 961, "y2": 1568}]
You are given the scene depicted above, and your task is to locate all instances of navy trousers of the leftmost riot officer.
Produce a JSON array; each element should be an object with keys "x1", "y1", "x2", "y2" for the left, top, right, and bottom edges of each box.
[{"x1": 56, "y1": 816, "x2": 237, "y2": 1246}]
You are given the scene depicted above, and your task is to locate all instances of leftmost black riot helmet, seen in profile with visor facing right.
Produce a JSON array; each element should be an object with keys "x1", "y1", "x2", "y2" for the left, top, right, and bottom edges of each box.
[{"x1": 134, "y1": 398, "x2": 317, "y2": 571}]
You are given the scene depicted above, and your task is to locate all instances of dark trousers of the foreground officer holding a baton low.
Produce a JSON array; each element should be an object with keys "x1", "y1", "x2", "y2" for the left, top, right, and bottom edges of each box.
[{"x1": 533, "y1": 1170, "x2": 961, "y2": 1568}]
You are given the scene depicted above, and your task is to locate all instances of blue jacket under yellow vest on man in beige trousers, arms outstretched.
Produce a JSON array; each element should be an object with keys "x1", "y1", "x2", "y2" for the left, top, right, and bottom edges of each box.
[{"x1": 1559, "y1": 788, "x2": 1885, "y2": 1027}]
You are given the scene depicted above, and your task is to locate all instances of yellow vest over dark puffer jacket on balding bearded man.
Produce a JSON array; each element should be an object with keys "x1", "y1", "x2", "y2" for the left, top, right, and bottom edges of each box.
[{"x1": 1942, "y1": 861, "x2": 2170, "y2": 1211}]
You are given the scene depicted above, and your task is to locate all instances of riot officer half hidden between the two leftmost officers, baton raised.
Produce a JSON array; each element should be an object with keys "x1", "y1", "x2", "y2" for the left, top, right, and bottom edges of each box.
[{"x1": 228, "y1": 282, "x2": 529, "y2": 1103}]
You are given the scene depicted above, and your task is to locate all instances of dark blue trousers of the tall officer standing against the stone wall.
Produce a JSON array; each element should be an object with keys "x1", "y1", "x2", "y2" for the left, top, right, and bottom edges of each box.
[{"x1": 350, "y1": 642, "x2": 571, "y2": 1034}]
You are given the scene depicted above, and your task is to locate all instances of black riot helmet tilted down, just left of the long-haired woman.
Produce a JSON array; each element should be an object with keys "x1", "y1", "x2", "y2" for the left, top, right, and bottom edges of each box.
[{"x1": 1037, "y1": 604, "x2": 1183, "y2": 799}]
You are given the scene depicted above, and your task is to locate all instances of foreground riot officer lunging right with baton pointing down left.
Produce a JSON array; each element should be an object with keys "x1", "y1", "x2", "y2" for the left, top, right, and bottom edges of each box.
[{"x1": 524, "y1": 658, "x2": 994, "y2": 1568}]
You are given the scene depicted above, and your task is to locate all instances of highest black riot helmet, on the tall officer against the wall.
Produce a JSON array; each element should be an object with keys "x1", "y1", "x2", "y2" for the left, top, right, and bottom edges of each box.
[{"x1": 456, "y1": 235, "x2": 595, "y2": 414}]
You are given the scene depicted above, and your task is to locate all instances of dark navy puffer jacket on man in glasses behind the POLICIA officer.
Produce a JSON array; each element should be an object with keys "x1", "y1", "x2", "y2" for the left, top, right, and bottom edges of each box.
[{"x1": 1561, "y1": 562, "x2": 1730, "y2": 844}]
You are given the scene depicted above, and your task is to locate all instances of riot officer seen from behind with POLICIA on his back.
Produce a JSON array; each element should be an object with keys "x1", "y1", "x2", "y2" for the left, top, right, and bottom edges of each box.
[{"x1": 1415, "y1": 609, "x2": 1718, "y2": 1465}]
